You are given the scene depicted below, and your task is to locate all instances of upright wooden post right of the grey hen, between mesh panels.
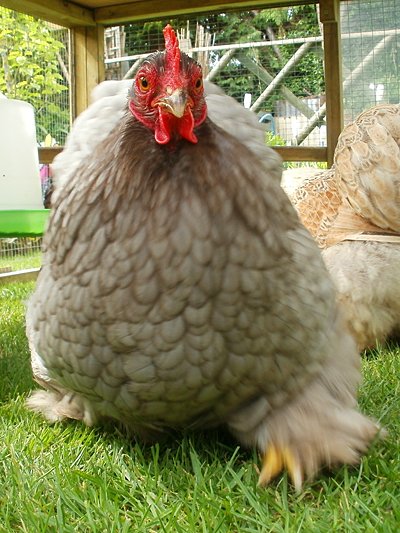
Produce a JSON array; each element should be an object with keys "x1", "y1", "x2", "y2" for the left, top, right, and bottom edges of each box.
[{"x1": 319, "y1": 0, "x2": 343, "y2": 166}]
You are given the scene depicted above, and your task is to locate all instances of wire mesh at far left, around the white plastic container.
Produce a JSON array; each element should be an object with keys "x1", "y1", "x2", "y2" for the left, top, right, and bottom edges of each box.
[{"x1": 0, "y1": 7, "x2": 71, "y2": 274}]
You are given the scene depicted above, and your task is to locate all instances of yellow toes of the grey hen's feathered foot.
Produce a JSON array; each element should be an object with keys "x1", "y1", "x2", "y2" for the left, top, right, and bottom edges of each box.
[{"x1": 258, "y1": 444, "x2": 303, "y2": 490}]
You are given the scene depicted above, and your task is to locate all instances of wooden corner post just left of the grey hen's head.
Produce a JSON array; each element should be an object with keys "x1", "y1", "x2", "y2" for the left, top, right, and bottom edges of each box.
[{"x1": 73, "y1": 25, "x2": 104, "y2": 116}]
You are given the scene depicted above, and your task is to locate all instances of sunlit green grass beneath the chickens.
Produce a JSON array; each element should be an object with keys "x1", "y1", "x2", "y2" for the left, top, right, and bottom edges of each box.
[{"x1": 0, "y1": 284, "x2": 400, "y2": 533}]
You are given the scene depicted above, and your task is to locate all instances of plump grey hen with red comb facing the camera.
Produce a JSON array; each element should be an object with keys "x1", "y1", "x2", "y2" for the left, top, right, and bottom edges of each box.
[{"x1": 27, "y1": 26, "x2": 379, "y2": 489}]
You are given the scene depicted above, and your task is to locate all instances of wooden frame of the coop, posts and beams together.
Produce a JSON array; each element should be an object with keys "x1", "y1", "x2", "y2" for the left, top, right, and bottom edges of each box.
[{"x1": 0, "y1": 0, "x2": 343, "y2": 166}]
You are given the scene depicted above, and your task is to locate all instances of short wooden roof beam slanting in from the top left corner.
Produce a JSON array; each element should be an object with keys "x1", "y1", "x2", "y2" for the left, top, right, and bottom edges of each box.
[{"x1": 0, "y1": 0, "x2": 96, "y2": 28}]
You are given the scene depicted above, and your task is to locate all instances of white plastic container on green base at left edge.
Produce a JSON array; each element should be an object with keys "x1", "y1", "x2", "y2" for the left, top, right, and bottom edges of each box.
[{"x1": 0, "y1": 98, "x2": 43, "y2": 210}]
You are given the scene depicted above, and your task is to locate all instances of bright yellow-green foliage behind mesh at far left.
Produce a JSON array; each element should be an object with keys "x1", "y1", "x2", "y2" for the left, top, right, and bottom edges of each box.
[{"x1": 0, "y1": 8, "x2": 69, "y2": 143}]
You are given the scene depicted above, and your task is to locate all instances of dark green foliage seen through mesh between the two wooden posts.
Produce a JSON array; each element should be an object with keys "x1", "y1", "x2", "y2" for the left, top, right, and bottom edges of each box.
[{"x1": 125, "y1": 5, "x2": 324, "y2": 111}]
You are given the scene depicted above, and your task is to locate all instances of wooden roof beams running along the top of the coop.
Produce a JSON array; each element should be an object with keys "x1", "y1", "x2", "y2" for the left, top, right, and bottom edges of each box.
[{"x1": 0, "y1": 0, "x2": 314, "y2": 27}]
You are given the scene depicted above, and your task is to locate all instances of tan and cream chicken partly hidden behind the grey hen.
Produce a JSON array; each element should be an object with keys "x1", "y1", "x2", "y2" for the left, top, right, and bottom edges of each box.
[{"x1": 291, "y1": 104, "x2": 400, "y2": 351}]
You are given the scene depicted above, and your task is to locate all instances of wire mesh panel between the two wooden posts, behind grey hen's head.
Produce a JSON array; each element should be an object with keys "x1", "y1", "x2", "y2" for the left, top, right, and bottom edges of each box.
[{"x1": 105, "y1": 4, "x2": 326, "y2": 146}]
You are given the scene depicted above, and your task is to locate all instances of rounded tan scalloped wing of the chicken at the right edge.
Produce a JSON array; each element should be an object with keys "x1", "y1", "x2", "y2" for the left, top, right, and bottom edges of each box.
[{"x1": 335, "y1": 104, "x2": 400, "y2": 232}]
